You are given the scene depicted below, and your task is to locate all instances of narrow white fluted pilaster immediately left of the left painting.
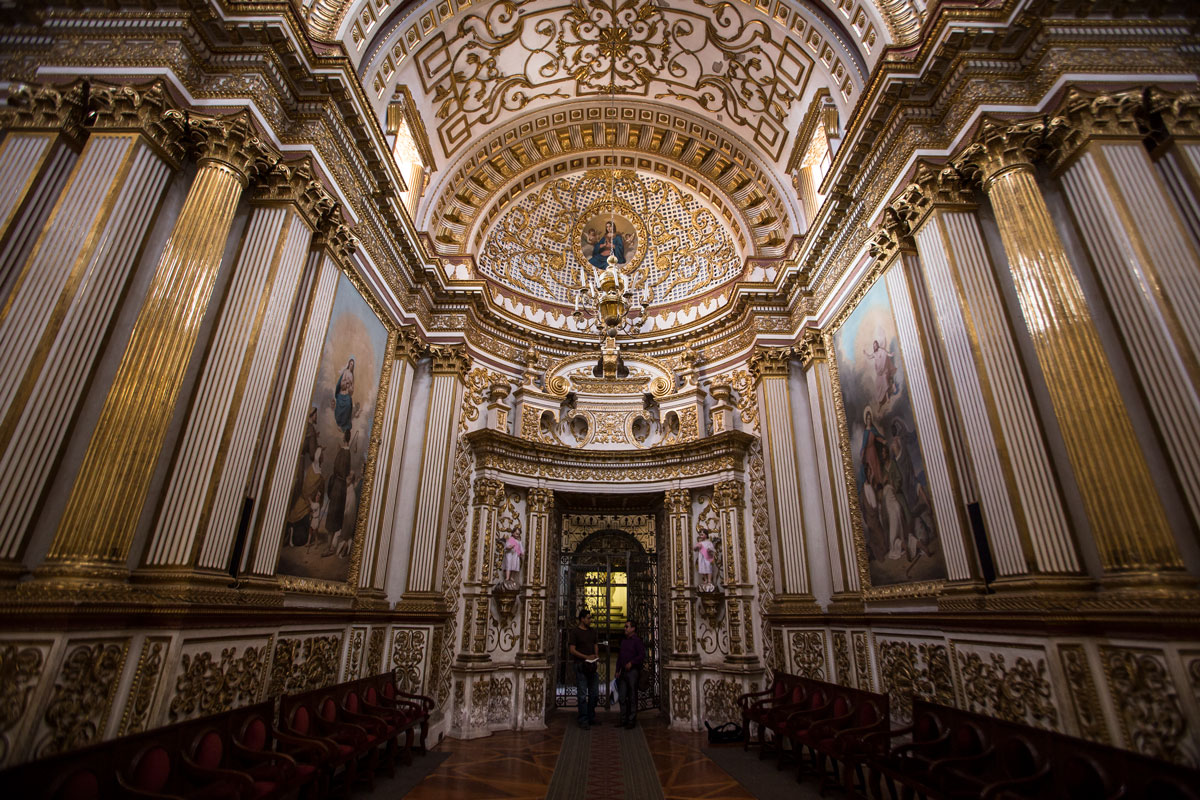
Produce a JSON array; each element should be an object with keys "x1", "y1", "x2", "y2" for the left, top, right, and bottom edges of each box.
[{"x1": 247, "y1": 225, "x2": 350, "y2": 584}]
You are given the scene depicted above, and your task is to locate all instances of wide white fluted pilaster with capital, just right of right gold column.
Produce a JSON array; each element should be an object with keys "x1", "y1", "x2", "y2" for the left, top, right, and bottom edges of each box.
[{"x1": 1052, "y1": 90, "x2": 1200, "y2": 528}]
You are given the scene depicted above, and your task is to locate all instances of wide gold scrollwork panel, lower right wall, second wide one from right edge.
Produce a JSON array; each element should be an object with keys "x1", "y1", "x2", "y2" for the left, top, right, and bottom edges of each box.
[{"x1": 950, "y1": 640, "x2": 1063, "y2": 732}]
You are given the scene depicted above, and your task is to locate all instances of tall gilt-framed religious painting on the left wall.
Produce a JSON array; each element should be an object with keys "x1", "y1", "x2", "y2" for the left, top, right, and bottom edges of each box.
[{"x1": 278, "y1": 275, "x2": 388, "y2": 583}]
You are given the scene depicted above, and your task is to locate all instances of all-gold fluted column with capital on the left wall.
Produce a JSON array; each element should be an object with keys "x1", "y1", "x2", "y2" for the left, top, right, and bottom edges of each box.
[{"x1": 41, "y1": 112, "x2": 276, "y2": 579}]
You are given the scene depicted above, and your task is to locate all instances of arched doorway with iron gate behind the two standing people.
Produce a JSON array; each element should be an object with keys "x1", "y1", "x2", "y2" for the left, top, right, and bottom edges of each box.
[{"x1": 554, "y1": 532, "x2": 659, "y2": 711}]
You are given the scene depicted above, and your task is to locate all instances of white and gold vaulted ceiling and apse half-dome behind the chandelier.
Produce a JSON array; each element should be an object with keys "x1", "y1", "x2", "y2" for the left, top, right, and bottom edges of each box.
[{"x1": 338, "y1": 0, "x2": 902, "y2": 340}]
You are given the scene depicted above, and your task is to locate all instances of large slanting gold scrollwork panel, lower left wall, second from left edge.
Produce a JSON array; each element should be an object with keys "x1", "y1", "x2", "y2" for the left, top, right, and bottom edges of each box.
[{"x1": 32, "y1": 637, "x2": 130, "y2": 758}]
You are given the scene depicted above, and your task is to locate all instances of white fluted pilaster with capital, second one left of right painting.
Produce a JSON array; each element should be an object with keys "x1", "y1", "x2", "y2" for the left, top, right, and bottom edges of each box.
[{"x1": 750, "y1": 348, "x2": 810, "y2": 600}]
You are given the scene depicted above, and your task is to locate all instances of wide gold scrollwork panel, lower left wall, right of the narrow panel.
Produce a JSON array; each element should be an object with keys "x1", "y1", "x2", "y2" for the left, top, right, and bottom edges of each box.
[{"x1": 168, "y1": 636, "x2": 272, "y2": 722}]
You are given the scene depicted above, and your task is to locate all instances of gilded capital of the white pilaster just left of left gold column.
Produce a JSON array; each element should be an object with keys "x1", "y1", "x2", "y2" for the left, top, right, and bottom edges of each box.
[{"x1": 88, "y1": 80, "x2": 187, "y2": 167}]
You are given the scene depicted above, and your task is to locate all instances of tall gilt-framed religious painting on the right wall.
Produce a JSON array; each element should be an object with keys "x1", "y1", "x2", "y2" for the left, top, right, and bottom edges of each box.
[{"x1": 833, "y1": 281, "x2": 946, "y2": 587}]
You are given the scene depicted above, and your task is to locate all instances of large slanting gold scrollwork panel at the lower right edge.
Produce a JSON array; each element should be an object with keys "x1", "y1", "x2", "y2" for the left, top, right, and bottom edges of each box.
[{"x1": 1100, "y1": 645, "x2": 1196, "y2": 766}]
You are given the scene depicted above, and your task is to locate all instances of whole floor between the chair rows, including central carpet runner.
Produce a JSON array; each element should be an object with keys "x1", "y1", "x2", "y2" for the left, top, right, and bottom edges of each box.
[{"x1": 371, "y1": 712, "x2": 763, "y2": 800}]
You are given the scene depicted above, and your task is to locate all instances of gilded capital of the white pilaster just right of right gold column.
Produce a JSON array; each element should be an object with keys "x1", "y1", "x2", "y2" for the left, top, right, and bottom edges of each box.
[{"x1": 1046, "y1": 86, "x2": 1148, "y2": 170}]
